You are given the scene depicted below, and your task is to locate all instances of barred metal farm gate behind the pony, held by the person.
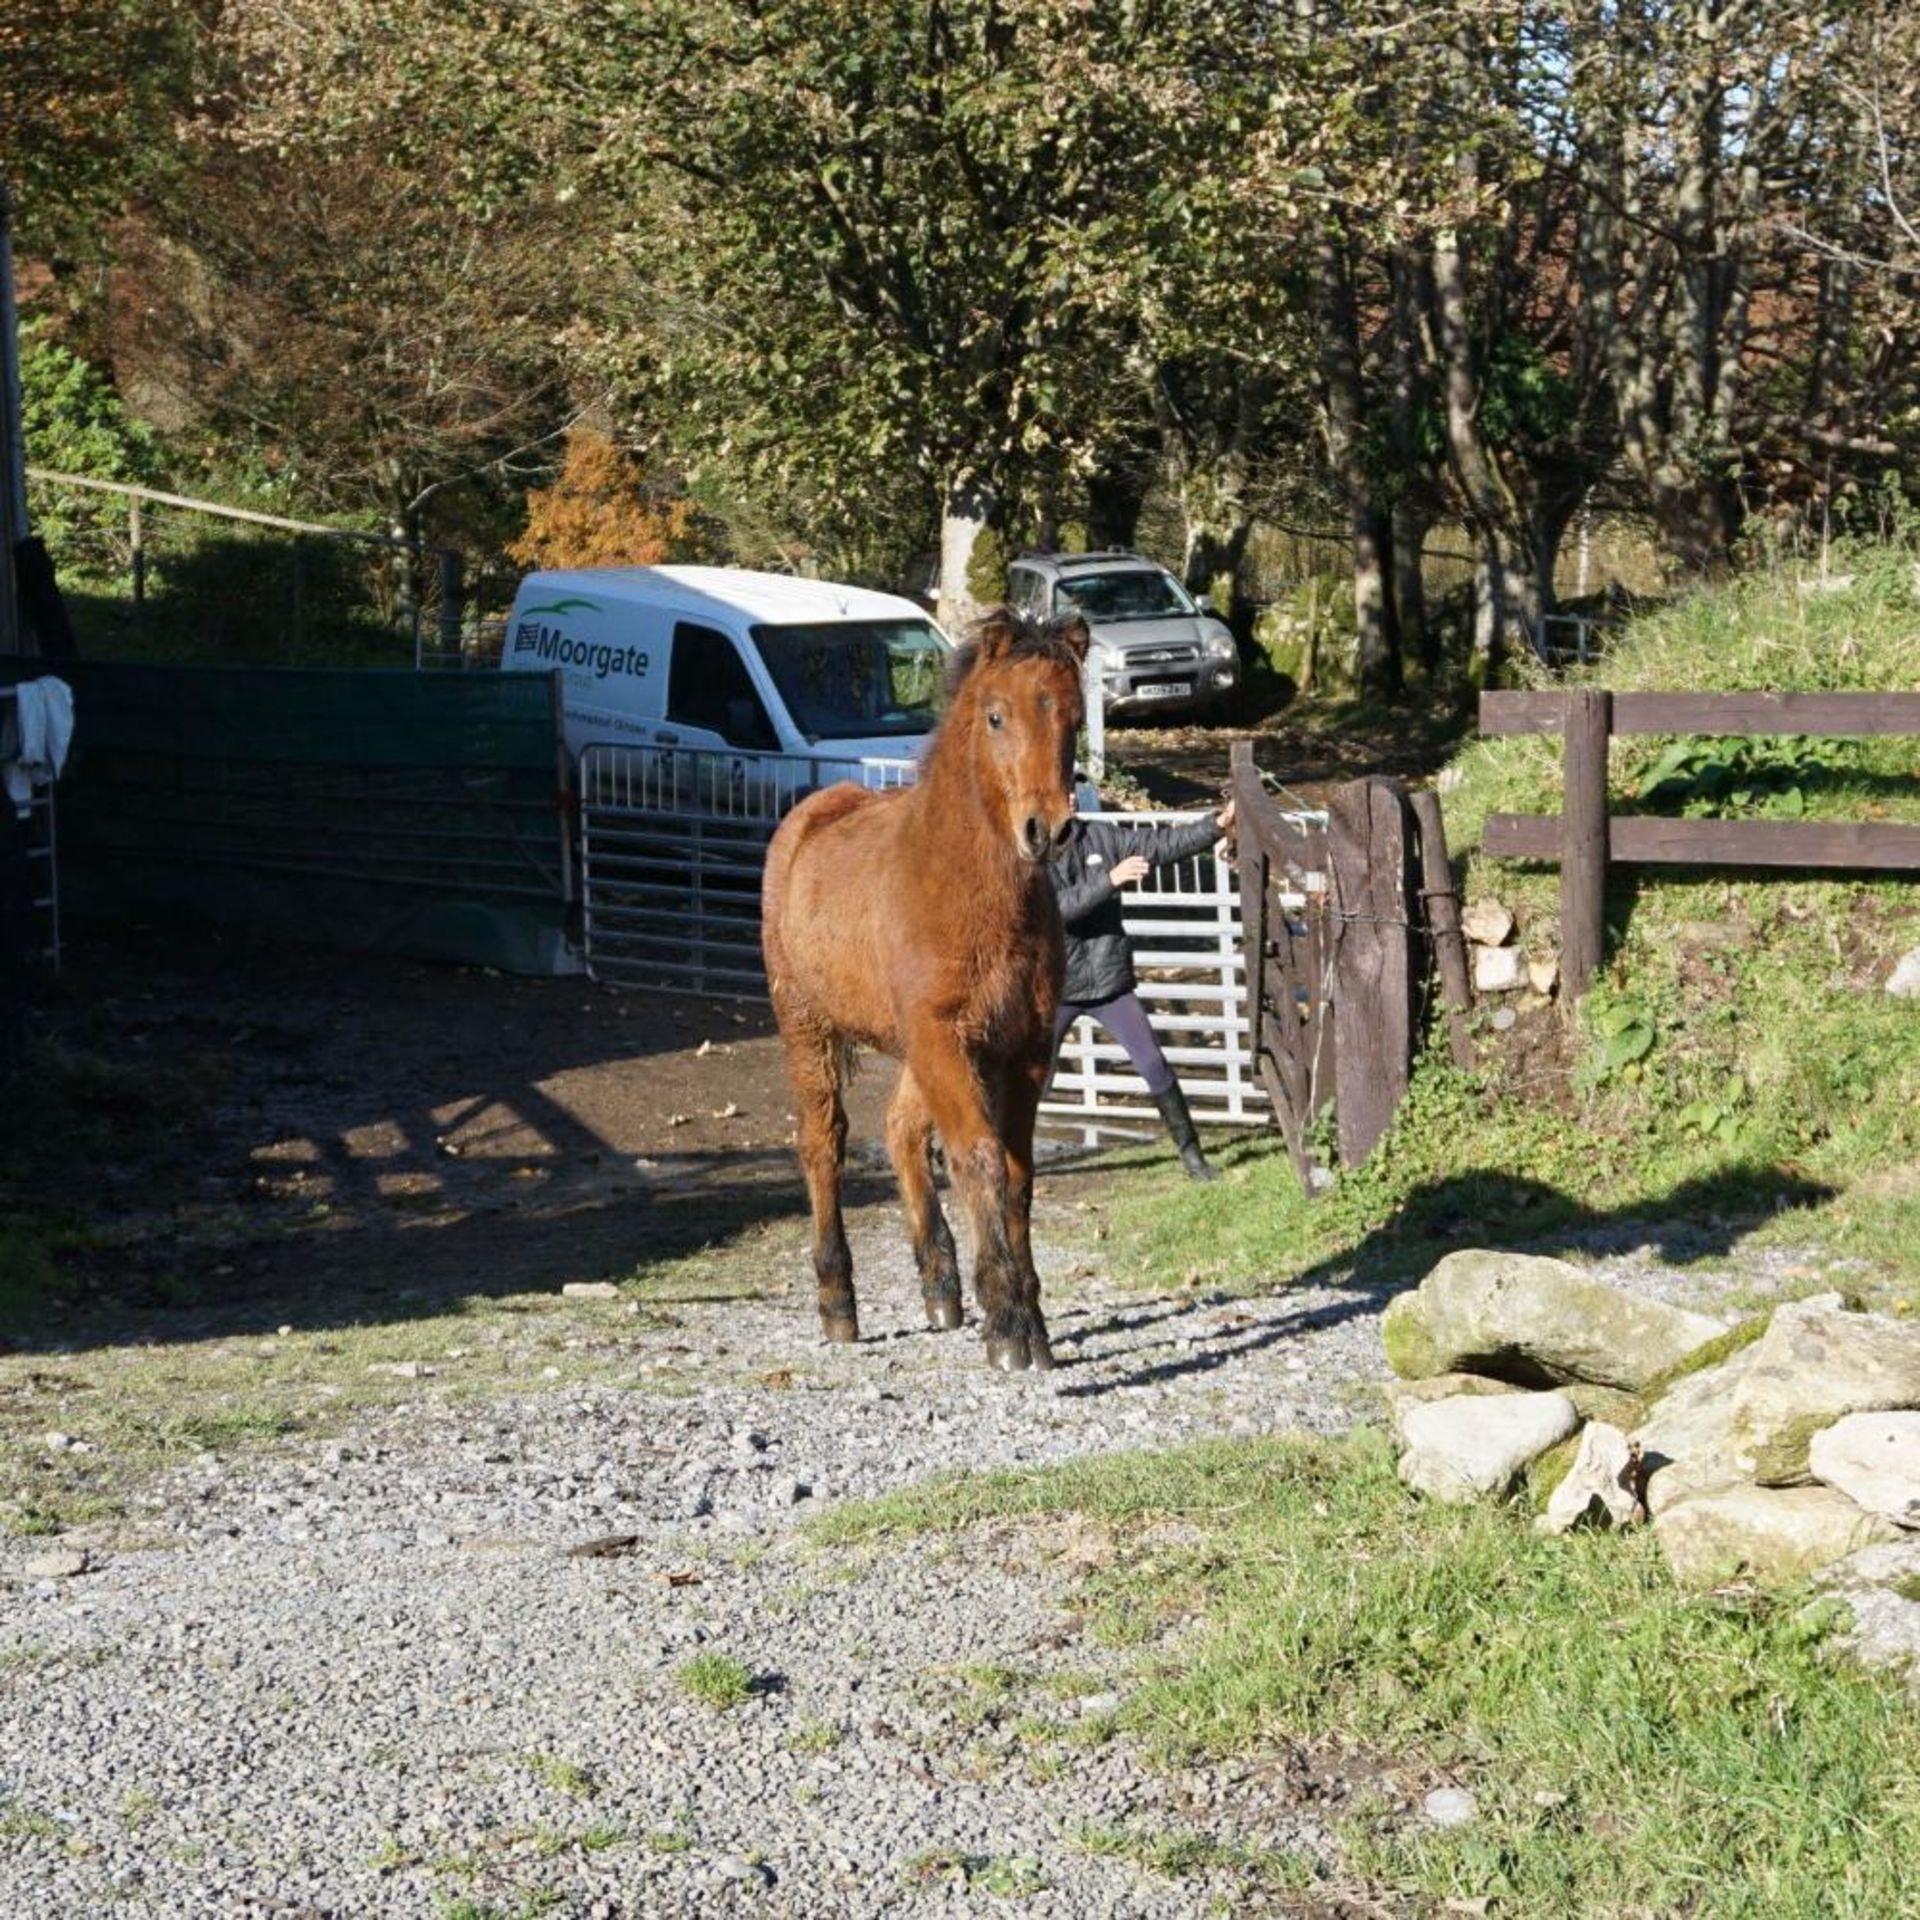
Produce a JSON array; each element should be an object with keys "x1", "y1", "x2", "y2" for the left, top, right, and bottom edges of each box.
[{"x1": 580, "y1": 745, "x2": 1313, "y2": 1144}]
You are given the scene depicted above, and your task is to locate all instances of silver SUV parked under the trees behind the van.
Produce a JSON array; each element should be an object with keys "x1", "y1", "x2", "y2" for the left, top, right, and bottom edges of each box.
[{"x1": 1006, "y1": 549, "x2": 1240, "y2": 714}]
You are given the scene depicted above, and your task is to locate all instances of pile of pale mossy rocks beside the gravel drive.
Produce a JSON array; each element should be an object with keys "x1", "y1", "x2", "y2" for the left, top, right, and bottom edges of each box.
[{"x1": 1384, "y1": 1252, "x2": 1920, "y2": 1678}]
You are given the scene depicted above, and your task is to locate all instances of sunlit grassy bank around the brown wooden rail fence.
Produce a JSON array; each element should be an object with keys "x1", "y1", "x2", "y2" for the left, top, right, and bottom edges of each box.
[{"x1": 1114, "y1": 533, "x2": 1920, "y2": 1296}]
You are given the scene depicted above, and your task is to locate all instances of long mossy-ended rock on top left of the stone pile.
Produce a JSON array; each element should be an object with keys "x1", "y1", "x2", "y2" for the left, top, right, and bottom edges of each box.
[{"x1": 1380, "y1": 1250, "x2": 1726, "y2": 1392}]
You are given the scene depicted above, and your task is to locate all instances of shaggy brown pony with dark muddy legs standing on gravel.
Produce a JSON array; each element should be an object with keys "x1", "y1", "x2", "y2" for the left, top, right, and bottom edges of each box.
[{"x1": 760, "y1": 607, "x2": 1087, "y2": 1373}]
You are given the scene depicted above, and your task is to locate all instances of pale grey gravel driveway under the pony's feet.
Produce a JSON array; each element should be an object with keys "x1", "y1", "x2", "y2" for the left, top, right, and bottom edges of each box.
[{"x1": 0, "y1": 1182, "x2": 1413, "y2": 1916}]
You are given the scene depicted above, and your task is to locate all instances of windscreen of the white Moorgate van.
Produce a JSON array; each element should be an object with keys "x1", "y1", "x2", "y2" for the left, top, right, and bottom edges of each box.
[{"x1": 753, "y1": 620, "x2": 947, "y2": 739}]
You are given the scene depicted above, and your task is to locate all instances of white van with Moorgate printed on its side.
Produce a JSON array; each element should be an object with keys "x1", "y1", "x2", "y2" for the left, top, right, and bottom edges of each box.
[{"x1": 499, "y1": 566, "x2": 950, "y2": 778}]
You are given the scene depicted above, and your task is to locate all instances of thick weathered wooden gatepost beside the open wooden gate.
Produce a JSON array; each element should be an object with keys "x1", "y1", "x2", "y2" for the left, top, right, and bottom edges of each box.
[{"x1": 1323, "y1": 780, "x2": 1415, "y2": 1167}]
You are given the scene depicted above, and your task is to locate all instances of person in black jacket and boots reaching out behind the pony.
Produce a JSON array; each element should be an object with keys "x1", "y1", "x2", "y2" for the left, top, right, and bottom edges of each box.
[{"x1": 1048, "y1": 801, "x2": 1233, "y2": 1181}]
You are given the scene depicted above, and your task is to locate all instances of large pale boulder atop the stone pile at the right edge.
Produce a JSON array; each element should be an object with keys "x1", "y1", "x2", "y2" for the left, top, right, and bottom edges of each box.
[{"x1": 1728, "y1": 1294, "x2": 1920, "y2": 1486}]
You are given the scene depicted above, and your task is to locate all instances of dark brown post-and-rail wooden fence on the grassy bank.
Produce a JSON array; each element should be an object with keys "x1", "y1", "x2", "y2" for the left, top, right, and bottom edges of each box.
[{"x1": 1480, "y1": 687, "x2": 1920, "y2": 1002}]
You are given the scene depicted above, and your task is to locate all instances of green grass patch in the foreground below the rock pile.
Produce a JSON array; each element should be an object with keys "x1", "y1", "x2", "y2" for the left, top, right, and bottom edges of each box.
[{"x1": 816, "y1": 1434, "x2": 1920, "y2": 1916}]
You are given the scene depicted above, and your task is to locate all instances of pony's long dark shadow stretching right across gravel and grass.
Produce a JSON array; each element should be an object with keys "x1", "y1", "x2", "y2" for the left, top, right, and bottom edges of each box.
[{"x1": 1054, "y1": 1167, "x2": 1834, "y2": 1400}]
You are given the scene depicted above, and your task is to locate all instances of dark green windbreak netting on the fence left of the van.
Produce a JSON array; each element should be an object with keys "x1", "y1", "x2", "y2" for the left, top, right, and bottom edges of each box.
[{"x1": 10, "y1": 662, "x2": 570, "y2": 973}]
